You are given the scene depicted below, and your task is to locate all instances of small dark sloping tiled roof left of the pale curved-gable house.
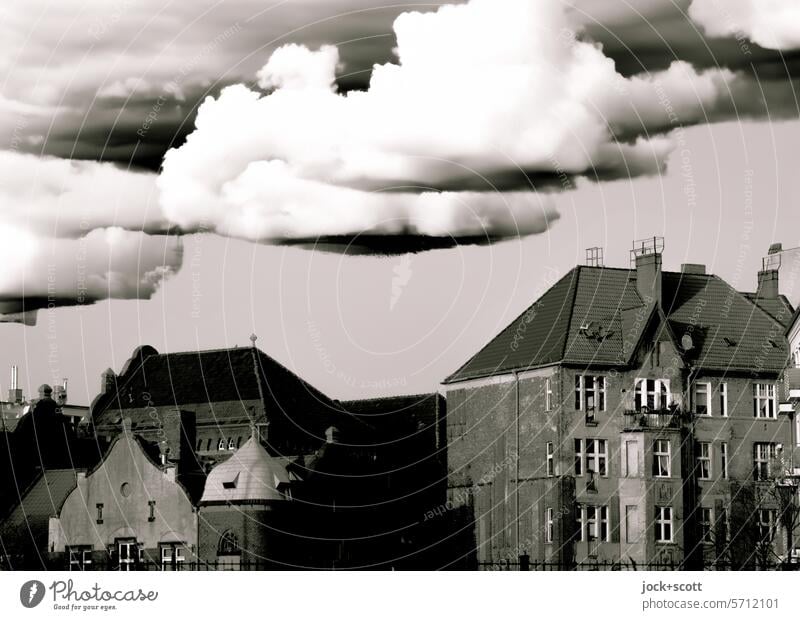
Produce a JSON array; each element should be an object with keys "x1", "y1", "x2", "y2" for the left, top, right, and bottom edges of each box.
[{"x1": 0, "y1": 469, "x2": 76, "y2": 551}]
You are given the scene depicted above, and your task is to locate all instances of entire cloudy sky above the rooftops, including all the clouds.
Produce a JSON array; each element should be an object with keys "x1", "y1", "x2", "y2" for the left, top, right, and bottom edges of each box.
[{"x1": 0, "y1": 0, "x2": 800, "y2": 403}]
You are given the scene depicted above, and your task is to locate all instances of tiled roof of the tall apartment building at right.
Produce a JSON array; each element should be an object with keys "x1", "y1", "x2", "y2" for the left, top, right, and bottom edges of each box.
[{"x1": 445, "y1": 266, "x2": 791, "y2": 383}]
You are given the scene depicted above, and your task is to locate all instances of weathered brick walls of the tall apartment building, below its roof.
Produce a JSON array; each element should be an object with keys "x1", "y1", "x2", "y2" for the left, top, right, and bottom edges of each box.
[{"x1": 447, "y1": 332, "x2": 791, "y2": 566}]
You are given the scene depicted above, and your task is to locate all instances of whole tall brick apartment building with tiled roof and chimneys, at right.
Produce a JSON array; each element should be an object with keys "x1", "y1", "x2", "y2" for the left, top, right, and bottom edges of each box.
[{"x1": 443, "y1": 238, "x2": 793, "y2": 568}]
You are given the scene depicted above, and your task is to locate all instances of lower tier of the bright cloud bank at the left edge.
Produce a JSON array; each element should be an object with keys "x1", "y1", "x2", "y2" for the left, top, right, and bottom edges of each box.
[{"x1": 0, "y1": 228, "x2": 183, "y2": 321}]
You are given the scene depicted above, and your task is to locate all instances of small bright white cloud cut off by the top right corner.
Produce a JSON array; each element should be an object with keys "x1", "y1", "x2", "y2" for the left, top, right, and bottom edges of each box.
[{"x1": 689, "y1": 0, "x2": 800, "y2": 50}]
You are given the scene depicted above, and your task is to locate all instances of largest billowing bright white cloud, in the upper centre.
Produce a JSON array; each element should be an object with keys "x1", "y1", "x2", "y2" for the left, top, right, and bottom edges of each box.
[{"x1": 158, "y1": 0, "x2": 748, "y2": 252}]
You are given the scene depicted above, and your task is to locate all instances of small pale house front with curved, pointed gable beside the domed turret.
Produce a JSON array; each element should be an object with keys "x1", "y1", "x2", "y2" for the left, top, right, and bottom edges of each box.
[{"x1": 48, "y1": 420, "x2": 197, "y2": 570}]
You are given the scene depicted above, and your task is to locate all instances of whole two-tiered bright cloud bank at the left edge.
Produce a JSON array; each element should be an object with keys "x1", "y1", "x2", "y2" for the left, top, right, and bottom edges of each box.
[{"x1": 0, "y1": 151, "x2": 182, "y2": 322}]
